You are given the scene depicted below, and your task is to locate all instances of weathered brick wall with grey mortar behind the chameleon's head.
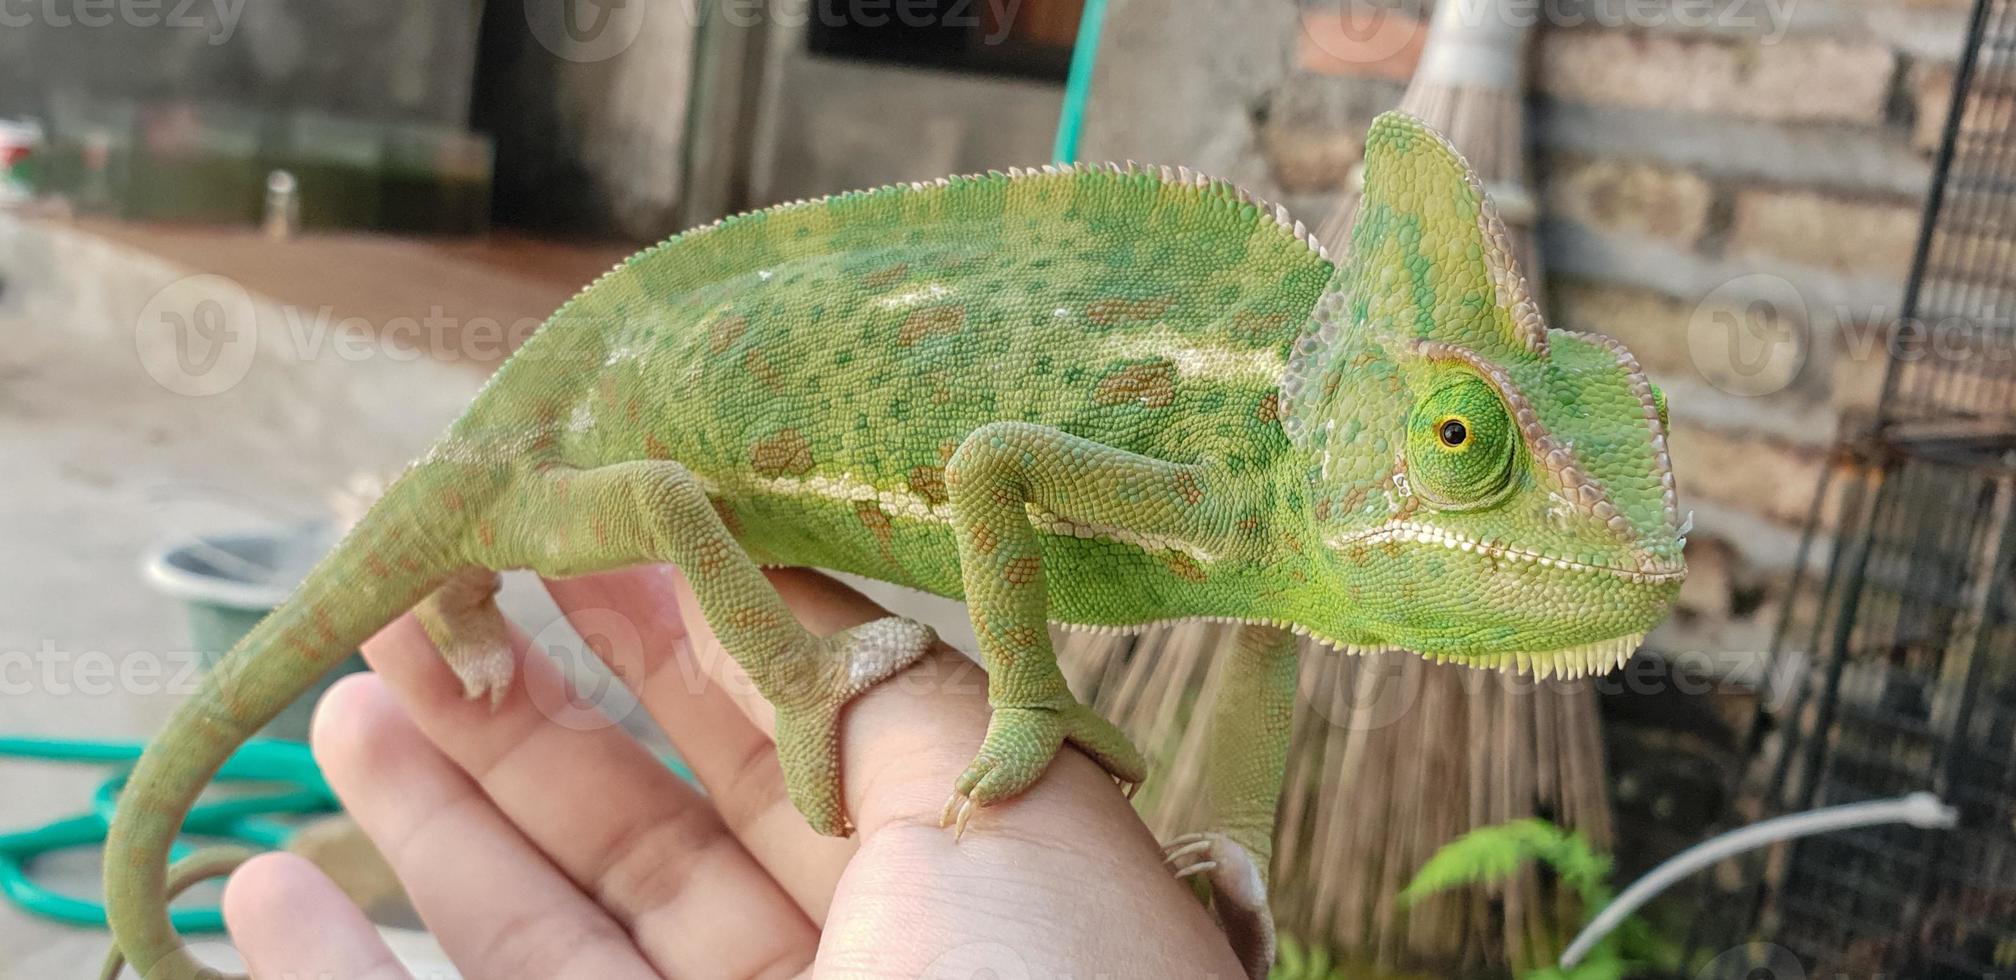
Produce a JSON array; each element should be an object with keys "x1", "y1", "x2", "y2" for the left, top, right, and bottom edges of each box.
[{"x1": 1087, "y1": 0, "x2": 1970, "y2": 653}]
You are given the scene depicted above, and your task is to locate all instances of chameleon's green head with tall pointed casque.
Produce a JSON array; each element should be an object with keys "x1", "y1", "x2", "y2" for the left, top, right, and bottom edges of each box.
[{"x1": 1284, "y1": 113, "x2": 1685, "y2": 673}]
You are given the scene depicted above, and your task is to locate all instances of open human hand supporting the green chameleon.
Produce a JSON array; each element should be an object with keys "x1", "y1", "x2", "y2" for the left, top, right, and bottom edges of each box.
[{"x1": 212, "y1": 569, "x2": 1244, "y2": 980}]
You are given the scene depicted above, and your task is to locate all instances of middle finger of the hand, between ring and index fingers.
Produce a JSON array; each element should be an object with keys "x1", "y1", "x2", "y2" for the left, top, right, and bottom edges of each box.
[{"x1": 365, "y1": 617, "x2": 818, "y2": 976}]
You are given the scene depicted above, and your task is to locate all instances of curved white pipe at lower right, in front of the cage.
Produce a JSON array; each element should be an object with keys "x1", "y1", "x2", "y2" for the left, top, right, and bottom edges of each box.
[{"x1": 1560, "y1": 792, "x2": 1960, "y2": 970}]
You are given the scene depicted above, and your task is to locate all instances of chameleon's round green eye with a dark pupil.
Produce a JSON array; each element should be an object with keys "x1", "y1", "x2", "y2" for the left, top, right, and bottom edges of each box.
[{"x1": 1407, "y1": 375, "x2": 1520, "y2": 510}]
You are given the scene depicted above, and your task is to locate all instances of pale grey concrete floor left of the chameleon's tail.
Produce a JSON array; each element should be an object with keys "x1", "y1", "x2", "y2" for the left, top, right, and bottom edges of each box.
[{"x1": 0, "y1": 278, "x2": 495, "y2": 978}]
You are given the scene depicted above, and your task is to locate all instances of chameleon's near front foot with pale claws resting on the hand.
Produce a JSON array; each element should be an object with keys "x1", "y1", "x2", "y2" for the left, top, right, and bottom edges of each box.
[{"x1": 937, "y1": 702, "x2": 1147, "y2": 839}]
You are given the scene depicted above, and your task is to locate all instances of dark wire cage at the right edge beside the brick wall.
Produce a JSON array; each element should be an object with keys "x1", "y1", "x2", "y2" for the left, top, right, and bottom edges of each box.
[{"x1": 1691, "y1": 0, "x2": 2016, "y2": 980}]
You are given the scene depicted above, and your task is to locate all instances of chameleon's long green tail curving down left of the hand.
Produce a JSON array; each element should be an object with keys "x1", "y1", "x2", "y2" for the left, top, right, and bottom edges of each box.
[{"x1": 105, "y1": 464, "x2": 468, "y2": 980}]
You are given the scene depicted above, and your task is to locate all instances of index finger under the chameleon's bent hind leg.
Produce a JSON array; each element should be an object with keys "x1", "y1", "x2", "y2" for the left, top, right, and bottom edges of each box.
[{"x1": 546, "y1": 567, "x2": 855, "y2": 922}]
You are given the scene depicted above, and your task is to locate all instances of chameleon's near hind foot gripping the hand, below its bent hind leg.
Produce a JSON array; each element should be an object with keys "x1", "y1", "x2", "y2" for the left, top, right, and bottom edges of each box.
[{"x1": 758, "y1": 617, "x2": 937, "y2": 837}]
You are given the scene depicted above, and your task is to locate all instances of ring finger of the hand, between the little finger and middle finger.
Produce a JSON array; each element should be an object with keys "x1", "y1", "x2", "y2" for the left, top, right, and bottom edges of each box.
[{"x1": 312, "y1": 673, "x2": 655, "y2": 978}]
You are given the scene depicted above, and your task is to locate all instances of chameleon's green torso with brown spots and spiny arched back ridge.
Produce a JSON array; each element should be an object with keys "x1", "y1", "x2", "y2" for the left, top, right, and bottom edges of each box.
[{"x1": 460, "y1": 167, "x2": 1333, "y2": 621}]
